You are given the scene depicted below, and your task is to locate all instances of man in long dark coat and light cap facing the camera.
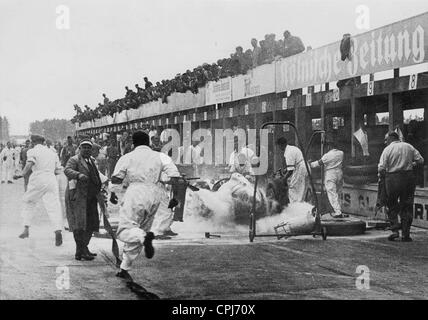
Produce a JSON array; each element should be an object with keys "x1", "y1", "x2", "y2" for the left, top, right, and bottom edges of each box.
[{"x1": 64, "y1": 140, "x2": 103, "y2": 260}]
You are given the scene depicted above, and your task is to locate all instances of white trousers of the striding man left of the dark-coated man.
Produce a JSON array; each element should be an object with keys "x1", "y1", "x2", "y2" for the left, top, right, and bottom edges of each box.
[{"x1": 22, "y1": 173, "x2": 63, "y2": 231}]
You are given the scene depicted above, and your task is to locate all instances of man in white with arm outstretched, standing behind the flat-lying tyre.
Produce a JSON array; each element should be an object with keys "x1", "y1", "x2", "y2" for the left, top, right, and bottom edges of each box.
[{"x1": 311, "y1": 143, "x2": 345, "y2": 218}]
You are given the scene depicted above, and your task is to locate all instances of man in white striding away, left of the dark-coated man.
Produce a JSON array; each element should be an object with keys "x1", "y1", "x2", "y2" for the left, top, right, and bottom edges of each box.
[{"x1": 16, "y1": 135, "x2": 63, "y2": 246}]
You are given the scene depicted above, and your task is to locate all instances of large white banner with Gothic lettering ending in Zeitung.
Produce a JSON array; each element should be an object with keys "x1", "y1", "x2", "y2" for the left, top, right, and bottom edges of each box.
[{"x1": 276, "y1": 13, "x2": 428, "y2": 92}]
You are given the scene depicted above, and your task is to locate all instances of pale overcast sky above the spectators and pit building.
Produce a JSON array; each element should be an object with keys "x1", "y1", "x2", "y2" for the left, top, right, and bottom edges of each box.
[{"x1": 0, "y1": 0, "x2": 428, "y2": 135}]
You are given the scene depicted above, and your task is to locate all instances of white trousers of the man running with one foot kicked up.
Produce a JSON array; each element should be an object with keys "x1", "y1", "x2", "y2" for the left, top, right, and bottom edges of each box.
[{"x1": 117, "y1": 184, "x2": 160, "y2": 270}]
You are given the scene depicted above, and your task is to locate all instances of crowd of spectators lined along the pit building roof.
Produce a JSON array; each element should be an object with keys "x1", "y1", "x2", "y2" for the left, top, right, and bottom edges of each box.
[{"x1": 72, "y1": 31, "x2": 305, "y2": 123}]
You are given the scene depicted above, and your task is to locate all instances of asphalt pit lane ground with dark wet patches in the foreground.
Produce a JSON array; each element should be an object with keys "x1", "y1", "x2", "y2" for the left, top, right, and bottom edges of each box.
[{"x1": 0, "y1": 181, "x2": 428, "y2": 300}]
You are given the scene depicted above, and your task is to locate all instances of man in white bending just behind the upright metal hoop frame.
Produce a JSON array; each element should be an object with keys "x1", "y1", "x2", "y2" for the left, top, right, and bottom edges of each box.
[{"x1": 276, "y1": 137, "x2": 308, "y2": 203}]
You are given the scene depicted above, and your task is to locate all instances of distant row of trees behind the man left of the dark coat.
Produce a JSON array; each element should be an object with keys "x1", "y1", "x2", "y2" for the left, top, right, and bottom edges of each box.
[{"x1": 30, "y1": 119, "x2": 75, "y2": 142}]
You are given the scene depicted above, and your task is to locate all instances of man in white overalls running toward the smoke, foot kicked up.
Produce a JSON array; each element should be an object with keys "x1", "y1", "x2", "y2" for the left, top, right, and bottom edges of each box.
[{"x1": 111, "y1": 131, "x2": 180, "y2": 280}]
